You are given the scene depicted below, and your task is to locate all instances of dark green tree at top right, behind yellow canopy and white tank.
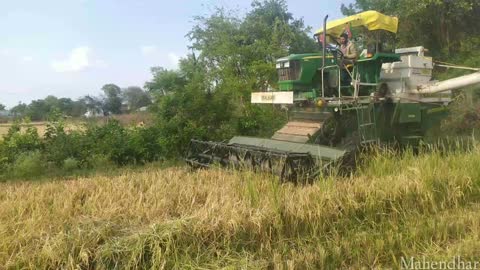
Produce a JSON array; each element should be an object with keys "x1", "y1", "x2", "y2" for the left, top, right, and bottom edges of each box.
[{"x1": 342, "y1": 0, "x2": 480, "y2": 60}]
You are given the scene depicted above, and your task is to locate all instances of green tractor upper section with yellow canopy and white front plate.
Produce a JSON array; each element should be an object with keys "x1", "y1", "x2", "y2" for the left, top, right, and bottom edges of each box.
[{"x1": 252, "y1": 11, "x2": 400, "y2": 106}]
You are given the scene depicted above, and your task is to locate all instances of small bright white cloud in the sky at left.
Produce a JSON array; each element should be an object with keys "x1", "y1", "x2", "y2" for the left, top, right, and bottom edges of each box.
[{"x1": 51, "y1": 46, "x2": 101, "y2": 72}]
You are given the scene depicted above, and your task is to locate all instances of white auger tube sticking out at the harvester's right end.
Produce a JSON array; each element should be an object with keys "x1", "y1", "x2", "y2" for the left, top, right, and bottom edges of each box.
[{"x1": 409, "y1": 72, "x2": 480, "y2": 94}]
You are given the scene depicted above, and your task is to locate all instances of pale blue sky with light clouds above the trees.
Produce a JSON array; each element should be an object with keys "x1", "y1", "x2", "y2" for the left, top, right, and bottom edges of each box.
[{"x1": 0, "y1": 0, "x2": 352, "y2": 108}]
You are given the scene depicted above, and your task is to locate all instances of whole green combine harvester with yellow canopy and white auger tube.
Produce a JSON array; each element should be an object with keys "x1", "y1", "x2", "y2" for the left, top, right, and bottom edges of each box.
[{"x1": 186, "y1": 11, "x2": 480, "y2": 181}]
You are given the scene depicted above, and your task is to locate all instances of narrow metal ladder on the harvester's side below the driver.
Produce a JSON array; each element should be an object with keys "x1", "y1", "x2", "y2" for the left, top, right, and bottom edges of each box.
[{"x1": 356, "y1": 104, "x2": 378, "y2": 143}]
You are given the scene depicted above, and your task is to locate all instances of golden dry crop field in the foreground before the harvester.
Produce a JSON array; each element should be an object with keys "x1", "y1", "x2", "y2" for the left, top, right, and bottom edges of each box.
[{"x1": 0, "y1": 149, "x2": 480, "y2": 269}]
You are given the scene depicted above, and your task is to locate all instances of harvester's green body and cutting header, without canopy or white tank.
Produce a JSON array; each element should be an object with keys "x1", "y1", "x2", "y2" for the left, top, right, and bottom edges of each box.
[{"x1": 185, "y1": 50, "x2": 447, "y2": 181}]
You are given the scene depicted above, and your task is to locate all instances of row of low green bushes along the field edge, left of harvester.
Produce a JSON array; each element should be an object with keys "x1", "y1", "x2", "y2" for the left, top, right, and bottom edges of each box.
[{"x1": 0, "y1": 102, "x2": 284, "y2": 180}]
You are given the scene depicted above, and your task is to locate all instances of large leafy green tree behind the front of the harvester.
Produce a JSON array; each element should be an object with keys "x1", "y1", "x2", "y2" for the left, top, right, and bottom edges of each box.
[{"x1": 145, "y1": 0, "x2": 308, "y2": 157}]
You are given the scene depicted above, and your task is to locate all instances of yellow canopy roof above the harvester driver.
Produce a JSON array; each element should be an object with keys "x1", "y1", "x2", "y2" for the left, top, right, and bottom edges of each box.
[{"x1": 315, "y1": 10, "x2": 398, "y2": 37}]
